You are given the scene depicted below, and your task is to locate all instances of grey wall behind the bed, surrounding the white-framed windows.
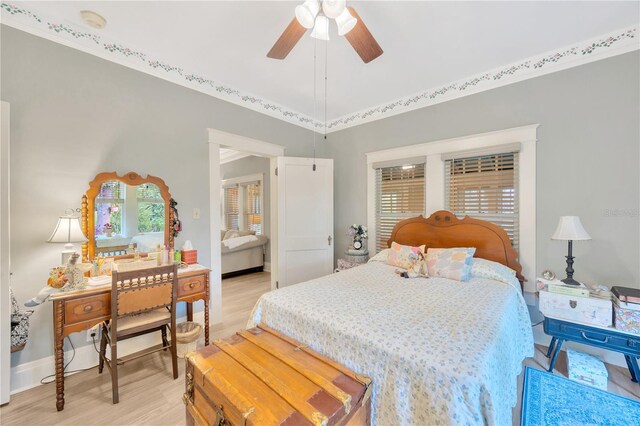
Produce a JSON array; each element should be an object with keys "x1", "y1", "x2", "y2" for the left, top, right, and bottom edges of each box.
[{"x1": 328, "y1": 51, "x2": 640, "y2": 288}]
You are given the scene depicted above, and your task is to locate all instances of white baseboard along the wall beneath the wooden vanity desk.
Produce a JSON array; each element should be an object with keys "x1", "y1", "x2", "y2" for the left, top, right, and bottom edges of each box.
[{"x1": 10, "y1": 311, "x2": 204, "y2": 395}]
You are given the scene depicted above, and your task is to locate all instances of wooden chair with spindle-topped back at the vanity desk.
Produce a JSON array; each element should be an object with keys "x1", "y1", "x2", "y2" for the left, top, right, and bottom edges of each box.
[{"x1": 98, "y1": 265, "x2": 178, "y2": 404}]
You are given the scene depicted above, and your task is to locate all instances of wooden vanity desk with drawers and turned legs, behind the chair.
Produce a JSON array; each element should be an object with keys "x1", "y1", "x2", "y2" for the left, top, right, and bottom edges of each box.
[{"x1": 51, "y1": 265, "x2": 210, "y2": 411}]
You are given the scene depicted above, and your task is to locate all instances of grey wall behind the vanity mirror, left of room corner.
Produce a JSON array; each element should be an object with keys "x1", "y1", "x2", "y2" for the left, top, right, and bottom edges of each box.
[{"x1": 1, "y1": 25, "x2": 324, "y2": 366}]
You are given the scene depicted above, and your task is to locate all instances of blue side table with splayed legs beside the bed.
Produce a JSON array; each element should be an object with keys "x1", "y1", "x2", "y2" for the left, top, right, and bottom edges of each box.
[{"x1": 544, "y1": 317, "x2": 640, "y2": 383}]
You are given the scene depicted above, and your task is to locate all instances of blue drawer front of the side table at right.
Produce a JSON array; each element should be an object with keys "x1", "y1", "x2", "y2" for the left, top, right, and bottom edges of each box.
[{"x1": 545, "y1": 319, "x2": 640, "y2": 356}]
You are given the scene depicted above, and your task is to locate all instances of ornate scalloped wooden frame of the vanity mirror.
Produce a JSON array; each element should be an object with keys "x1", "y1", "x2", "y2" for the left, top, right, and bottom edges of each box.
[{"x1": 80, "y1": 172, "x2": 174, "y2": 262}]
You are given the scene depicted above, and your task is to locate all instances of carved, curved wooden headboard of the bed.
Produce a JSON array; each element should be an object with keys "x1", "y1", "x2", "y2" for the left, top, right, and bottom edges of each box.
[{"x1": 387, "y1": 210, "x2": 524, "y2": 285}]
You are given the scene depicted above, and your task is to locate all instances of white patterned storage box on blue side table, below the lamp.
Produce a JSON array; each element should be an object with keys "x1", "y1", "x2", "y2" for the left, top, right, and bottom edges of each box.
[{"x1": 540, "y1": 290, "x2": 613, "y2": 327}]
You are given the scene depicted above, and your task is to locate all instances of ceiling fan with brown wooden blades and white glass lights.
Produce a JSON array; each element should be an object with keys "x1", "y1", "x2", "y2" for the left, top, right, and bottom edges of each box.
[{"x1": 267, "y1": 0, "x2": 383, "y2": 64}]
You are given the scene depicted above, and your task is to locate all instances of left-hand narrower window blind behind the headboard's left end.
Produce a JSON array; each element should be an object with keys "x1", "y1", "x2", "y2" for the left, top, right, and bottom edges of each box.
[{"x1": 376, "y1": 163, "x2": 425, "y2": 251}]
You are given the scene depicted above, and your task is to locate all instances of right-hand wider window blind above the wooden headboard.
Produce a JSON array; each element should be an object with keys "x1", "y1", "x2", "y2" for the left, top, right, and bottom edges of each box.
[{"x1": 444, "y1": 152, "x2": 519, "y2": 250}]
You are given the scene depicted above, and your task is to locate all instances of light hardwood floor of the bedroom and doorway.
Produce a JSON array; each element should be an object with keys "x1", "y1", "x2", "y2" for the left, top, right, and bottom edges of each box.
[{"x1": 0, "y1": 272, "x2": 640, "y2": 425}]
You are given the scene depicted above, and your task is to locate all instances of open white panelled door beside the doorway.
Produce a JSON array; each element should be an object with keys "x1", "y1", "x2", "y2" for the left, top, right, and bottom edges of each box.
[{"x1": 277, "y1": 157, "x2": 333, "y2": 287}]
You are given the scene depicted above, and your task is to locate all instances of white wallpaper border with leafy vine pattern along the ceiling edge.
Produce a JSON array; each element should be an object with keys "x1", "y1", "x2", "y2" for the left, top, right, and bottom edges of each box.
[{"x1": 0, "y1": 2, "x2": 640, "y2": 132}]
